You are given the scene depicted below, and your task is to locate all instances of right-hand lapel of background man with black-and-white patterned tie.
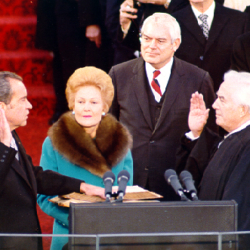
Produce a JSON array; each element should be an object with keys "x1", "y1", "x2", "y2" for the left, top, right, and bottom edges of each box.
[{"x1": 205, "y1": 4, "x2": 229, "y2": 53}]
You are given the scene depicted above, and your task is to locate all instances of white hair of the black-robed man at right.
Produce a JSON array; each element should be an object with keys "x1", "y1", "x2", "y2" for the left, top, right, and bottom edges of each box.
[{"x1": 224, "y1": 70, "x2": 250, "y2": 113}]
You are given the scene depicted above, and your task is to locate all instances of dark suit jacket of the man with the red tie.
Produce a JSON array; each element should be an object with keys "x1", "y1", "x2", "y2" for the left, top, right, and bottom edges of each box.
[{"x1": 110, "y1": 58, "x2": 215, "y2": 200}]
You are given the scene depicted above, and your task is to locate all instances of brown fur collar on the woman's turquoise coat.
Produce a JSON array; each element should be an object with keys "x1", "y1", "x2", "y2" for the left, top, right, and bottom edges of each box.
[{"x1": 48, "y1": 112, "x2": 132, "y2": 177}]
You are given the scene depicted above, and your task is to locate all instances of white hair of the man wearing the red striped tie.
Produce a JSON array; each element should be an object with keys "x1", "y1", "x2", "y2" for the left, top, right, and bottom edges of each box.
[{"x1": 141, "y1": 13, "x2": 181, "y2": 44}]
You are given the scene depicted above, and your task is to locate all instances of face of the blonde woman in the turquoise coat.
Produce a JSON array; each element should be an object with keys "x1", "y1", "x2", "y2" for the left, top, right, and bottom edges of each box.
[{"x1": 74, "y1": 86, "x2": 104, "y2": 137}]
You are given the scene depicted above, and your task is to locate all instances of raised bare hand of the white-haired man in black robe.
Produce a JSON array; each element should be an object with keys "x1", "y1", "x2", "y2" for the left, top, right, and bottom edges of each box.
[{"x1": 188, "y1": 92, "x2": 209, "y2": 137}]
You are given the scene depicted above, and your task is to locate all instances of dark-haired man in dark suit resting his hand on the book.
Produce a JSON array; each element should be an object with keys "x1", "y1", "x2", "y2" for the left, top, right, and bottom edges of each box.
[{"x1": 0, "y1": 72, "x2": 104, "y2": 250}]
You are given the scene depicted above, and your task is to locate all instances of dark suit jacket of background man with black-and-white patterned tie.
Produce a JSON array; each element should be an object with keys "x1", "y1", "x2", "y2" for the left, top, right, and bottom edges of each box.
[{"x1": 172, "y1": 3, "x2": 248, "y2": 91}]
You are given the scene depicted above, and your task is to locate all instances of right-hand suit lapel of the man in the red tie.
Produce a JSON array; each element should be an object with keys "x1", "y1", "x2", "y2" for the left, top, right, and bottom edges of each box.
[{"x1": 154, "y1": 57, "x2": 183, "y2": 132}]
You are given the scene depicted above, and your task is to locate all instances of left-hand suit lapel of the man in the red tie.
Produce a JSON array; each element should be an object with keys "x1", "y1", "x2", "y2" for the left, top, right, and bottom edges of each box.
[{"x1": 131, "y1": 58, "x2": 153, "y2": 130}]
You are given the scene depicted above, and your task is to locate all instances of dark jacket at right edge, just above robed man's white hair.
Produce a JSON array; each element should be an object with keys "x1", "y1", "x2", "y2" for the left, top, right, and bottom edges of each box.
[{"x1": 231, "y1": 32, "x2": 250, "y2": 72}]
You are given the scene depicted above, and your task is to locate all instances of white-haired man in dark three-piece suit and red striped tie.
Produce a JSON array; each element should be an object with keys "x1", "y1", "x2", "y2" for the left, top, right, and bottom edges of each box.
[{"x1": 110, "y1": 13, "x2": 215, "y2": 200}]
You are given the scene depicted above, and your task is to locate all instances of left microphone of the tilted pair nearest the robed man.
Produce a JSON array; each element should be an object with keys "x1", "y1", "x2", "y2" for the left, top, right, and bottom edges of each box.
[{"x1": 164, "y1": 169, "x2": 190, "y2": 201}]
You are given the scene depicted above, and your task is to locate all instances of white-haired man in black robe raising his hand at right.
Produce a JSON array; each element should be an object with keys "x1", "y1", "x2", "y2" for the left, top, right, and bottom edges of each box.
[{"x1": 177, "y1": 71, "x2": 250, "y2": 230}]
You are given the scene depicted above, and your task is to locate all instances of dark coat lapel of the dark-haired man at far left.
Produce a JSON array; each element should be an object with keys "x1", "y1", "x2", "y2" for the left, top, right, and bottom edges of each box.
[{"x1": 12, "y1": 132, "x2": 37, "y2": 194}]
